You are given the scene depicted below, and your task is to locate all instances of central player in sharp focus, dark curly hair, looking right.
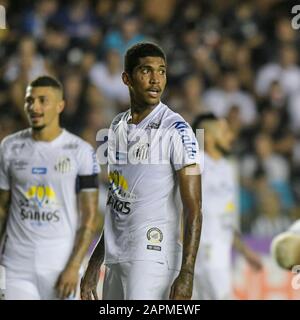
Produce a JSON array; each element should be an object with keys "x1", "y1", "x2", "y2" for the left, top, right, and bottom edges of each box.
[{"x1": 81, "y1": 43, "x2": 201, "y2": 300}]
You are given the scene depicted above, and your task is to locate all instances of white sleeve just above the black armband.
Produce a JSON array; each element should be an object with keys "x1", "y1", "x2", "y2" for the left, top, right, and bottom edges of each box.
[{"x1": 77, "y1": 143, "x2": 101, "y2": 176}]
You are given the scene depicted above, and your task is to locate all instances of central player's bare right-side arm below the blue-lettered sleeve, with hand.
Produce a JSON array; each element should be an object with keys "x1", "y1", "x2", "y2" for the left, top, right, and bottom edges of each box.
[{"x1": 170, "y1": 165, "x2": 202, "y2": 299}]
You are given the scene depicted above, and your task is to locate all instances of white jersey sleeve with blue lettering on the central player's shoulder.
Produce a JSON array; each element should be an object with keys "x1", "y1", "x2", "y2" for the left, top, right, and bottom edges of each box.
[{"x1": 170, "y1": 121, "x2": 200, "y2": 171}]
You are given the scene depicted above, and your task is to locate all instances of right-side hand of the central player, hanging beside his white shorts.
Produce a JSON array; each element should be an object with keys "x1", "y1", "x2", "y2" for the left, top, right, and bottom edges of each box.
[{"x1": 169, "y1": 271, "x2": 194, "y2": 300}]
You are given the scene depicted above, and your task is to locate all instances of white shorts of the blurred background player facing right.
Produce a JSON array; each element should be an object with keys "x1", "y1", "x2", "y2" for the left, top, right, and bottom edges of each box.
[{"x1": 192, "y1": 267, "x2": 232, "y2": 300}]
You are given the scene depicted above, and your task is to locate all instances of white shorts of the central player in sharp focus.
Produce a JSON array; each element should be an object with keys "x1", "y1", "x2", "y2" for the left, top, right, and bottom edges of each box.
[{"x1": 103, "y1": 261, "x2": 179, "y2": 300}]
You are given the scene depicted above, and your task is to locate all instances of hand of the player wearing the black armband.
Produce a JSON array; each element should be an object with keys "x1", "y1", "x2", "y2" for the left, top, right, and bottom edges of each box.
[{"x1": 55, "y1": 265, "x2": 80, "y2": 299}]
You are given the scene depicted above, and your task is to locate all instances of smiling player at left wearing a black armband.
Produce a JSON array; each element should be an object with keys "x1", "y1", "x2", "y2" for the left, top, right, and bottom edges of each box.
[{"x1": 0, "y1": 76, "x2": 99, "y2": 300}]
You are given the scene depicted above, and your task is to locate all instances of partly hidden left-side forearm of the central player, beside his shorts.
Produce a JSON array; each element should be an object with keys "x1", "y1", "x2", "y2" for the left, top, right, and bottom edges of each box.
[{"x1": 80, "y1": 231, "x2": 105, "y2": 300}]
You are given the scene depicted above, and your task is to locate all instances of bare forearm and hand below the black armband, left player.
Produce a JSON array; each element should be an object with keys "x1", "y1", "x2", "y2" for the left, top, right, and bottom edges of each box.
[{"x1": 56, "y1": 190, "x2": 98, "y2": 298}]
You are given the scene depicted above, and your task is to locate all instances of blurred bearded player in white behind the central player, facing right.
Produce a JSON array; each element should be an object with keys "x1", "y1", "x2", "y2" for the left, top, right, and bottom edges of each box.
[{"x1": 193, "y1": 113, "x2": 262, "y2": 300}]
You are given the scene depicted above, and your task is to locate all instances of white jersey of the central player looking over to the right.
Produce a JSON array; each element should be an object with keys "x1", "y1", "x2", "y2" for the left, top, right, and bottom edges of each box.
[{"x1": 104, "y1": 103, "x2": 199, "y2": 272}]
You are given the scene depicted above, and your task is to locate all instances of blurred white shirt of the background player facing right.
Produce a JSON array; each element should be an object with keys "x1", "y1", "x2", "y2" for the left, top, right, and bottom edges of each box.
[{"x1": 197, "y1": 153, "x2": 237, "y2": 269}]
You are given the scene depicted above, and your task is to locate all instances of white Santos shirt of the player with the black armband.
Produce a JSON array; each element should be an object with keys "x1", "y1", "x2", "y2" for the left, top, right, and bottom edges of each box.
[{"x1": 0, "y1": 129, "x2": 99, "y2": 268}]
